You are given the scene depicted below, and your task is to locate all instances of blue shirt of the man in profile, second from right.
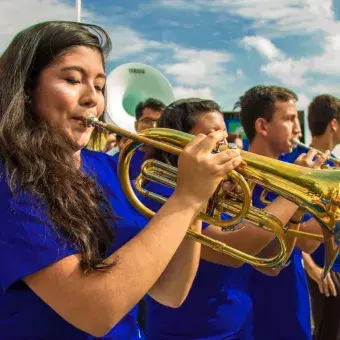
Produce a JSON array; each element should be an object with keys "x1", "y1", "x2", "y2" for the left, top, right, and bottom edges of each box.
[{"x1": 249, "y1": 149, "x2": 312, "y2": 340}]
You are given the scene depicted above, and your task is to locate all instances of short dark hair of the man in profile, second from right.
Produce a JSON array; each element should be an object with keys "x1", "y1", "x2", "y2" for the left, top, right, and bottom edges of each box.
[{"x1": 234, "y1": 85, "x2": 298, "y2": 143}]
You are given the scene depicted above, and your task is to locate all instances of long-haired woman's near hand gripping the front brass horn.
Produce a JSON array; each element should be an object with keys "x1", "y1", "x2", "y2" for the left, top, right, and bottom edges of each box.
[{"x1": 175, "y1": 131, "x2": 242, "y2": 206}]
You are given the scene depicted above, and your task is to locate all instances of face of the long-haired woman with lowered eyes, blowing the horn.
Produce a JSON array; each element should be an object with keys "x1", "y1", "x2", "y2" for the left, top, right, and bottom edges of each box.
[{"x1": 32, "y1": 46, "x2": 105, "y2": 149}]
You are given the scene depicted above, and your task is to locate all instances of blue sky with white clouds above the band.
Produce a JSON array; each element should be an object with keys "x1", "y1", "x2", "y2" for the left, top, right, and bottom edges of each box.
[{"x1": 0, "y1": 0, "x2": 340, "y2": 146}]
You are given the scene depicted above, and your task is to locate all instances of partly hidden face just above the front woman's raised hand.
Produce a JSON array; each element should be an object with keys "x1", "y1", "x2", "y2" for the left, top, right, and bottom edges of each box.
[{"x1": 189, "y1": 111, "x2": 227, "y2": 135}]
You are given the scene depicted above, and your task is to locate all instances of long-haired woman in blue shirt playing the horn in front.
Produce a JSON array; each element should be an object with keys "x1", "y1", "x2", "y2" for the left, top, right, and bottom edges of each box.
[{"x1": 0, "y1": 21, "x2": 241, "y2": 340}]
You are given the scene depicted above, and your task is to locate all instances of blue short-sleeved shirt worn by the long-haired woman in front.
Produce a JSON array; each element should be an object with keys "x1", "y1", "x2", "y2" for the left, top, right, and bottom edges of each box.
[{"x1": 0, "y1": 150, "x2": 147, "y2": 340}]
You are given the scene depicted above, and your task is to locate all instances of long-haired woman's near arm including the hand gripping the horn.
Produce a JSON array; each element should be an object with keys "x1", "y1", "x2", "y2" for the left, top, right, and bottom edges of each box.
[{"x1": 24, "y1": 132, "x2": 241, "y2": 336}]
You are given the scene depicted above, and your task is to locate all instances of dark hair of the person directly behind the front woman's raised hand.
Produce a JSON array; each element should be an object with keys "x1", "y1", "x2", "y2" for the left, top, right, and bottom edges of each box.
[{"x1": 147, "y1": 98, "x2": 222, "y2": 166}]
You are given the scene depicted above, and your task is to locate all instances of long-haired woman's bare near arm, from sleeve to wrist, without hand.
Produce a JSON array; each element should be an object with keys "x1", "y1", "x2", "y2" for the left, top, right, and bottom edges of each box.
[{"x1": 24, "y1": 196, "x2": 203, "y2": 336}]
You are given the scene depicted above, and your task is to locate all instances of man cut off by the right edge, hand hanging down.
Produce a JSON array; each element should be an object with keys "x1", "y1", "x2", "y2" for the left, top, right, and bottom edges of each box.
[{"x1": 303, "y1": 95, "x2": 340, "y2": 340}]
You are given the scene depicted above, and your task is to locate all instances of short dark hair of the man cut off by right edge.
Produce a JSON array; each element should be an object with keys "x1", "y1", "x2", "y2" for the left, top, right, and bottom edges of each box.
[{"x1": 308, "y1": 94, "x2": 340, "y2": 137}]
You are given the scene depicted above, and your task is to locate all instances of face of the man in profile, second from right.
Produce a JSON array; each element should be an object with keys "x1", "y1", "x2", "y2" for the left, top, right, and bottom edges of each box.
[{"x1": 265, "y1": 100, "x2": 301, "y2": 155}]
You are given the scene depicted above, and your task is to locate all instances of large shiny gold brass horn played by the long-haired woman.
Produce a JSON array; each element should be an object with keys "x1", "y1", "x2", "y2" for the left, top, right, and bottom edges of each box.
[{"x1": 84, "y1": 117, "x2": 340, "y2": 275}]
